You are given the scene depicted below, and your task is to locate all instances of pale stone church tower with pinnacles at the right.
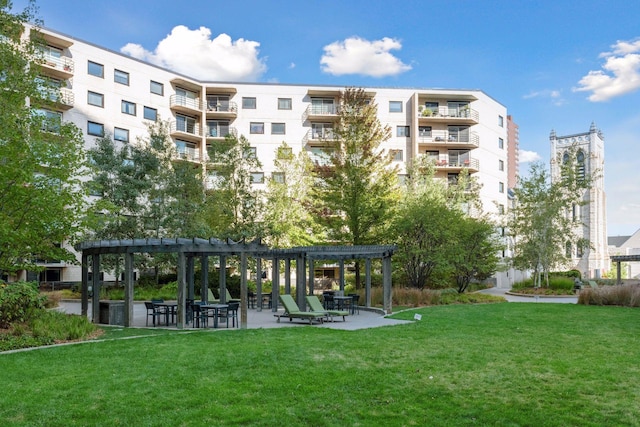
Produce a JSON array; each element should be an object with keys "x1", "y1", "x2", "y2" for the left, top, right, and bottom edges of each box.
[{"x1": 549, "y1": 123, "x2": 610, "y2": 279}]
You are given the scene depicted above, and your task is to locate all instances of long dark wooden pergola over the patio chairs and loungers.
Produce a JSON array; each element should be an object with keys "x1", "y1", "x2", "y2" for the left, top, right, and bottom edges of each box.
[{"x1": 76, "y1": 238, "x2": 396, "y2": 329}]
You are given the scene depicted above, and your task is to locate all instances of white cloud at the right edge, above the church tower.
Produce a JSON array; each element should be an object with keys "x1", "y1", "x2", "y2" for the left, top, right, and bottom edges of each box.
[{"x1": 573, "y1": 39, "x2": 640, "y2": 102}]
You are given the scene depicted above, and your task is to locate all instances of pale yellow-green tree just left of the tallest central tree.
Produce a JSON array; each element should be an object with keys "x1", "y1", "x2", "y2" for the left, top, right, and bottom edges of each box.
[{"x1": 264, "y1": 142, "x2": 321, "y2": 248}]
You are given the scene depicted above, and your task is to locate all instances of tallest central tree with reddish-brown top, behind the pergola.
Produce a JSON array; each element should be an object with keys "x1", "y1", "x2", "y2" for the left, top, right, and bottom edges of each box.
[{"x1": 316, "y1": 88, "x2": 398, "y2": 287}]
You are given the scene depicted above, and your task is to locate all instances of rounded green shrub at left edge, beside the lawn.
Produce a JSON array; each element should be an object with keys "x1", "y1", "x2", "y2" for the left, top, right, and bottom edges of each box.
[{"x1": 0, "y1": 282, "x2": 46, "y2": 328}]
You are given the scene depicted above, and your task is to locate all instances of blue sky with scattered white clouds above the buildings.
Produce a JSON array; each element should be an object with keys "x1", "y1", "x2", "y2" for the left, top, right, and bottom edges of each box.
[{"x1": 13, "y1": 0, "x2": 640, "y2": 235}]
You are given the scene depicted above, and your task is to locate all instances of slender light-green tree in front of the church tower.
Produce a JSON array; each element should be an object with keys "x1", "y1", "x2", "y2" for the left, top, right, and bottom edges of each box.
[{"x1": 506, "y1": 156, "x2": 592, "y2": 286}]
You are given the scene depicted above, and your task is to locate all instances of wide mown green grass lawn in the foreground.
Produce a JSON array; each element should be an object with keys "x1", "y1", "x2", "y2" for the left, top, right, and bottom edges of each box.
[{"x1": 0, "y1": 303, "x2": 640, "y2": 426}]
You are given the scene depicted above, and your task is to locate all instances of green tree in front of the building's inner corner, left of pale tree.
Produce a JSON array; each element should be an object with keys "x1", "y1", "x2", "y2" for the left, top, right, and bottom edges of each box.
[{"x1": 204, "y1": 134, "x2": 263, "y2": 240}]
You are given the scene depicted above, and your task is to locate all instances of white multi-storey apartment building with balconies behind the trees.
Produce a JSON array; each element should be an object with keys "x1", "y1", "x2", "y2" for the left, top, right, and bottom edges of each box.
[{"x1": 28, "y1": 29, "x2": 508, "y2": 281}]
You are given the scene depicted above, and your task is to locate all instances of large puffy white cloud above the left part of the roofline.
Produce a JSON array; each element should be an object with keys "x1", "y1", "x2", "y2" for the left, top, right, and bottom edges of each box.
[{"x1": 120, "y1": 25, "x2": 267, "y2": 81}]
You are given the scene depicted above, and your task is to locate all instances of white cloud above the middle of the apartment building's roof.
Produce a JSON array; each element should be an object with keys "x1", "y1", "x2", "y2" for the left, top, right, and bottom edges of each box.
[{"x1": 320, "y1": 37, "x2": 411, "y2": 77}]
